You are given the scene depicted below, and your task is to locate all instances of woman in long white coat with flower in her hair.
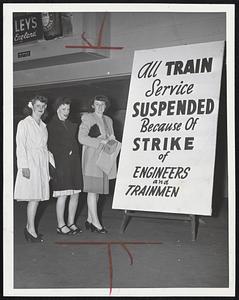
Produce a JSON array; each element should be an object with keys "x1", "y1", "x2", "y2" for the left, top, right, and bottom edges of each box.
[{"x1": 14, "y1": 96, "x2": 49, "y2": 242}]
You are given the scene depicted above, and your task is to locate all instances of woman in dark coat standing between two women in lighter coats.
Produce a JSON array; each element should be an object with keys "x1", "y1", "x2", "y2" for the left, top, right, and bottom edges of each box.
[{"x1": 48, "y1": 97, "x2": 83, "y2": 234}]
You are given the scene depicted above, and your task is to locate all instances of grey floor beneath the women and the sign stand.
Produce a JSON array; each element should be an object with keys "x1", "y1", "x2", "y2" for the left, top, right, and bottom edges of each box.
[{"x1": 14, "y1": 193, "x2": 229, "y2": 295}]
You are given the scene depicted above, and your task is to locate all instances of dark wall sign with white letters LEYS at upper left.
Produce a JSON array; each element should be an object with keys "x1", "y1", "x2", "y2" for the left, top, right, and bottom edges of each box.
[{"x1": 13, "y1": 13, "x2": 43, "y2": 45}]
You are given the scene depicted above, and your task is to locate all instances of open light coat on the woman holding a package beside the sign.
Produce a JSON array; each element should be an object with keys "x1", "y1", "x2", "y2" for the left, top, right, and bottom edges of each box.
[{"x1": 78, "y1": 113, "x2": 116, "y2": 179}]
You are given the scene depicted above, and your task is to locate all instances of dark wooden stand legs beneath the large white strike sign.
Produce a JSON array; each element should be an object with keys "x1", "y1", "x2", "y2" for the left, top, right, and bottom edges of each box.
[{"x1": 120, "y1": 210, "x2": 199, "y2": 241}]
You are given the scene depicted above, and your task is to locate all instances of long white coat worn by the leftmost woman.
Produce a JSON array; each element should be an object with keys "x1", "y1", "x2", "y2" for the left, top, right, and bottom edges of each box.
[{"x1": 14, "y1": 116, "x2": 49, "y2": 201}]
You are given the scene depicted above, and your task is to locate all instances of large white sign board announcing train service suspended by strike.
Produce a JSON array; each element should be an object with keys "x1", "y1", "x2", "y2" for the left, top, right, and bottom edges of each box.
[{"x1": 113, "y1": 41, "x2": 224, "y2": 215}]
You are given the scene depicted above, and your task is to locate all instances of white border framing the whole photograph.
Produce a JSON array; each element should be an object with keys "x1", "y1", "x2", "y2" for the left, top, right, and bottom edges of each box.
[{"x1": 3, "y1": 3, "x2": 236, "y2": 297}]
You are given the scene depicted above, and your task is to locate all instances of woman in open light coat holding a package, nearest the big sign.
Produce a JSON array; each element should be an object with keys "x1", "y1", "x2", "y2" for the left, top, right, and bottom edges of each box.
[{"x1": 78, "y1": 95, "x2": 116, "y2": 233}]
